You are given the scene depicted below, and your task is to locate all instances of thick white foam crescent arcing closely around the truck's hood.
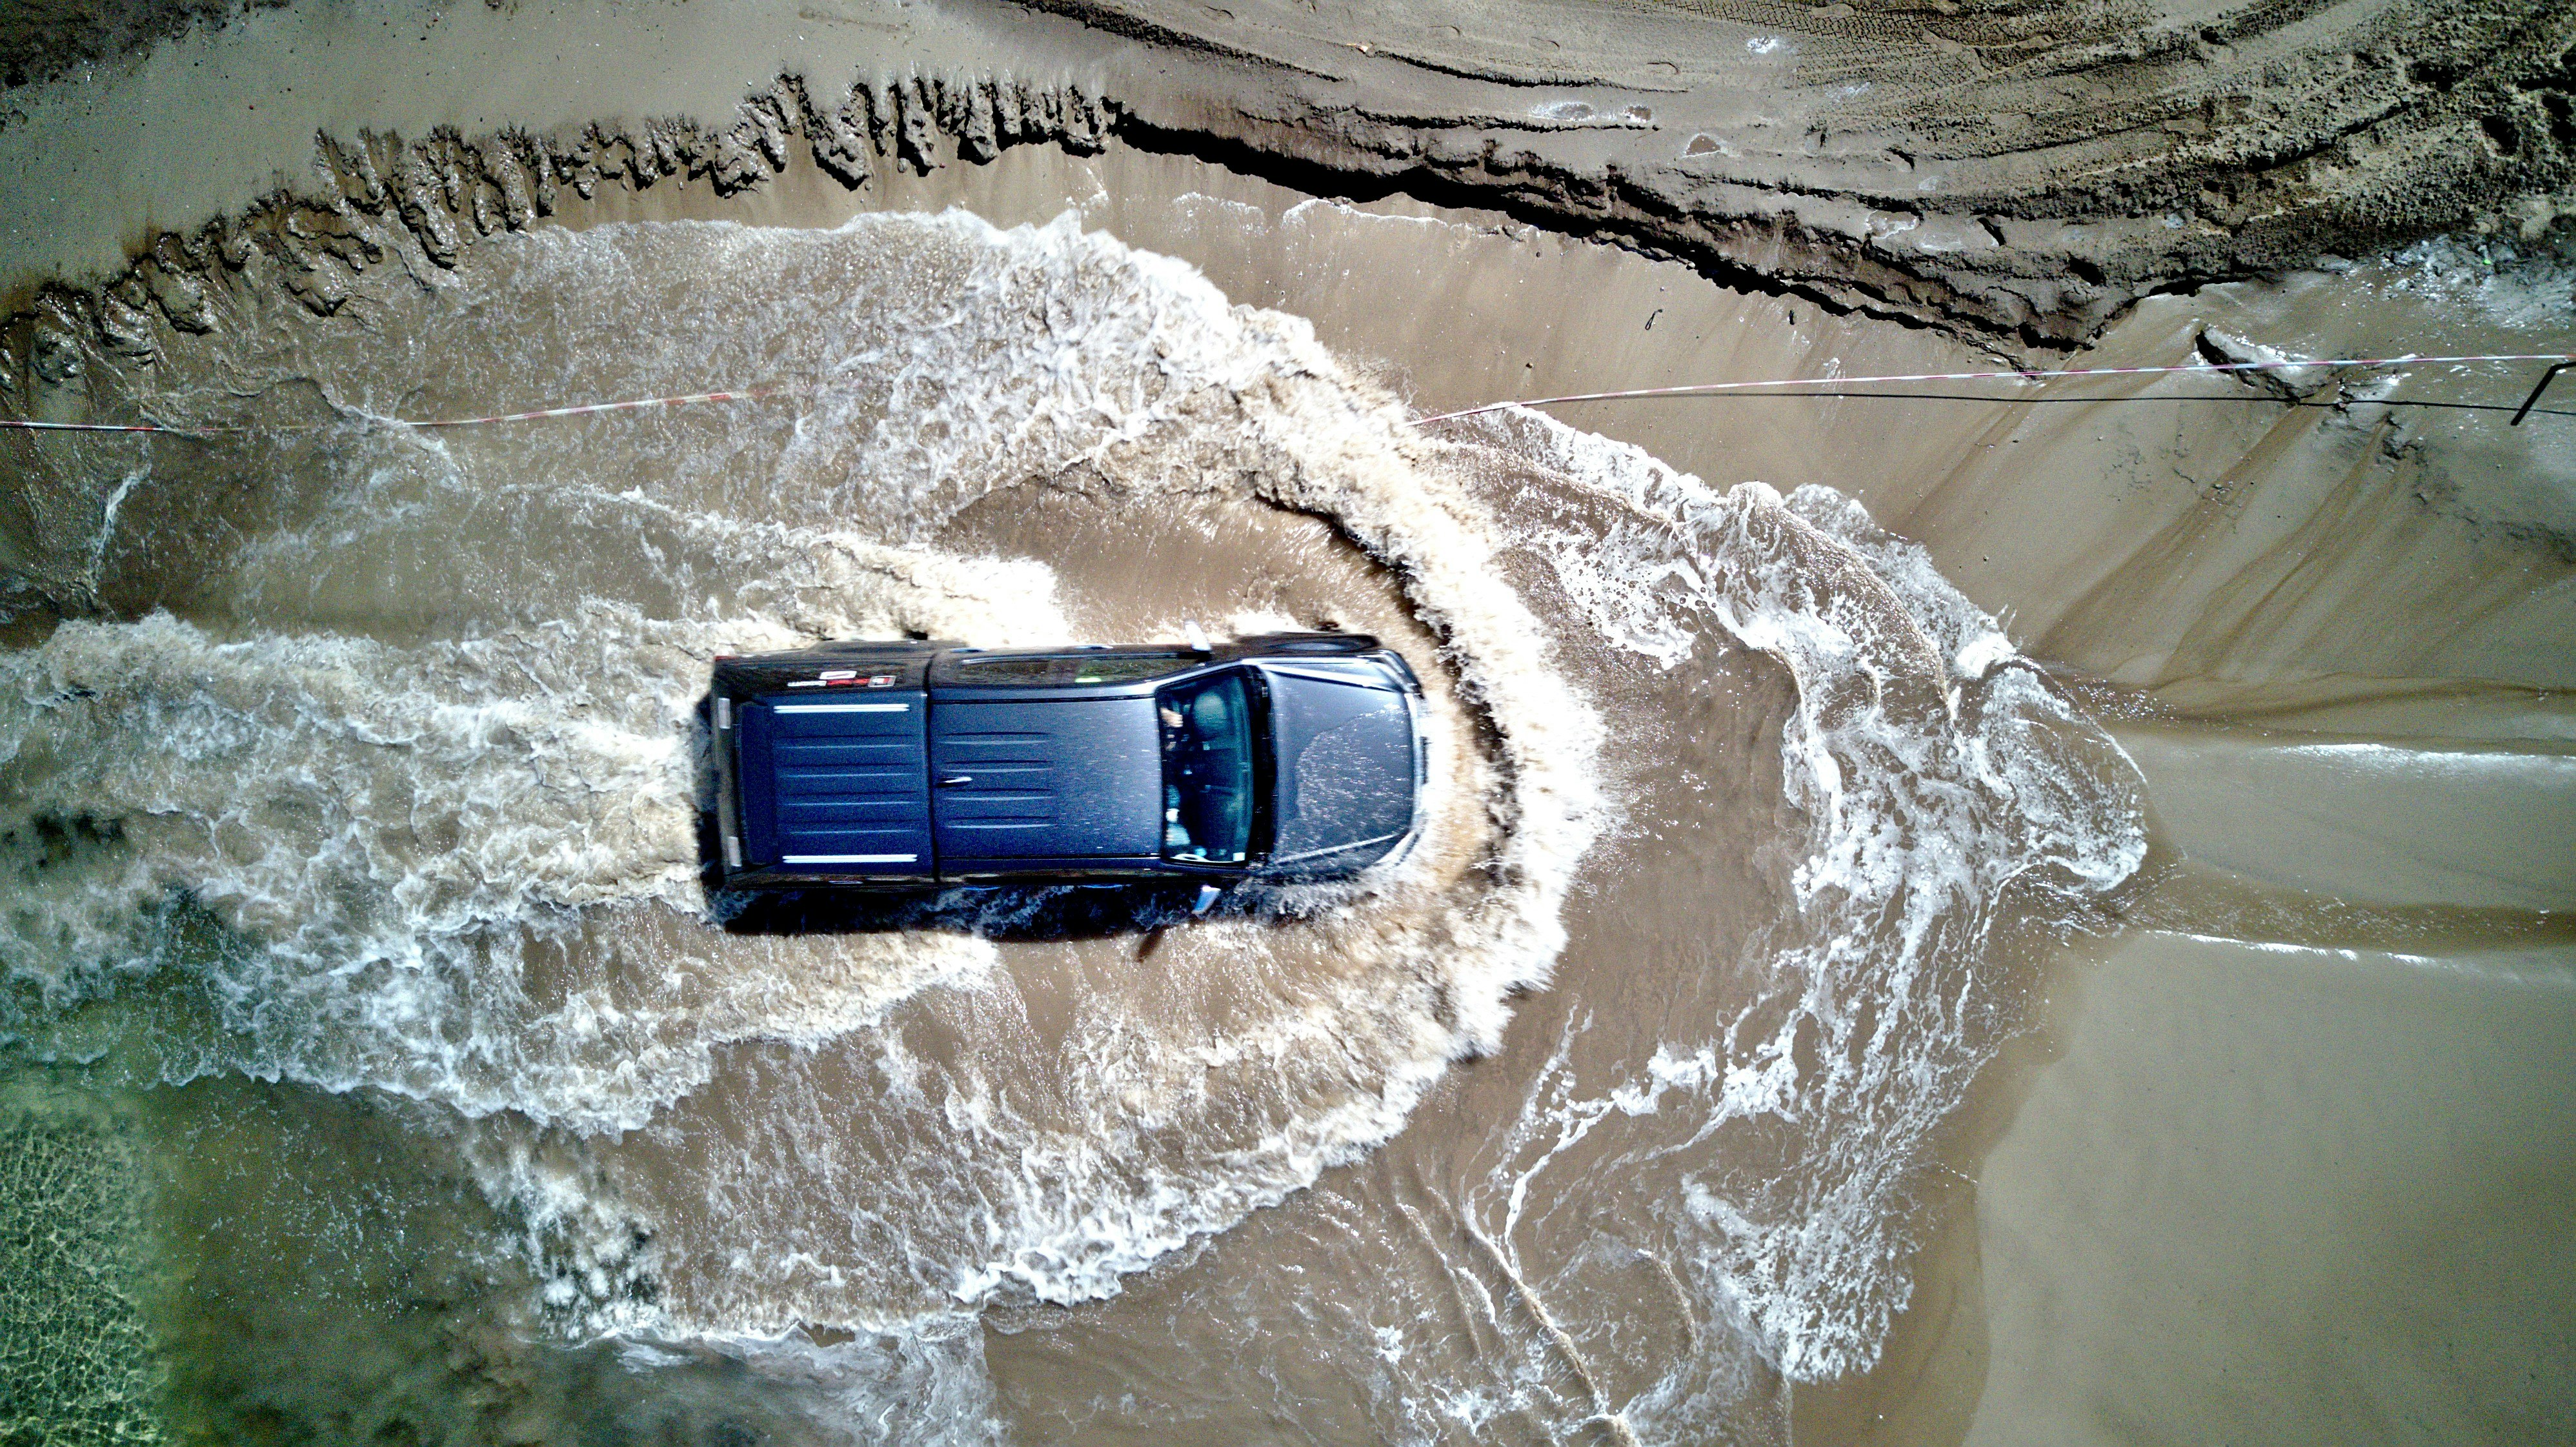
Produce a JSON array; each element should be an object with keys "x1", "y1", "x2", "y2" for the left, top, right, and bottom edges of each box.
[{"x1": 592, "y1": 214, "x2": 1597, "y2": 1328}]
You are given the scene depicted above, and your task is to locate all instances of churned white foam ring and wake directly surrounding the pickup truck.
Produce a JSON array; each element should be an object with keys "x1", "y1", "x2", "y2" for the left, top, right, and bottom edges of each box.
[{"x1": 13, "y1": 214, "x2": 1600, "y2": 1401}]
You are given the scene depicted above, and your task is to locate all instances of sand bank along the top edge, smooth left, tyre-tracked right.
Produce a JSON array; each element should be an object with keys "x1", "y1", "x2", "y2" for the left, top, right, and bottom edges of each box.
[{"x1": 0, "y1": 0, "x2": 2576, "y2": 345}]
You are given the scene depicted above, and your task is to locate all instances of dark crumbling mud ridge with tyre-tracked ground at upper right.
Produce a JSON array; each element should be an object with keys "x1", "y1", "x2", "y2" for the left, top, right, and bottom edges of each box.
[{"x1": 10, "y1": 0, "x2": 2576, "y2": 363}]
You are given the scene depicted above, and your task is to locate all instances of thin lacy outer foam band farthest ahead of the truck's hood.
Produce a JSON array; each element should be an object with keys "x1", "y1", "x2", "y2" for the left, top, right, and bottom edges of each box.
[{"x1": 1484, "y1": 412, "x2": 2146, "y2": 1390}]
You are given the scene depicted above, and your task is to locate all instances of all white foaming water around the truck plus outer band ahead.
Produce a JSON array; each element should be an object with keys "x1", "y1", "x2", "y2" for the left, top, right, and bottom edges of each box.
[{"x1": 0, "y1": 211, "x2": 2143, "y2": 1437}]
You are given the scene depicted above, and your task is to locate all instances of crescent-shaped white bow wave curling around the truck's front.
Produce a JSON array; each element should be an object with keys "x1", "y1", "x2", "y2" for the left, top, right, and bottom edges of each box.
[{"x1": 487, "y1": 214, "x2": 1600, "y2": 1324}]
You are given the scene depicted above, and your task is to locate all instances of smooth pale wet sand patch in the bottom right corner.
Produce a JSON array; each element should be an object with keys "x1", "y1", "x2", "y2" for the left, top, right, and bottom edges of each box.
[{"x1": 1966, "y1": 932, "x2": 2576, "y2": 1444}]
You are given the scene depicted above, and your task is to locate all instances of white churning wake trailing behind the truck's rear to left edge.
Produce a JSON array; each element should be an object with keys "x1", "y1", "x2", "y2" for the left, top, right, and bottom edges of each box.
[{"x1": 0, "y1": 607, "x2": 992, "y2": 1130}]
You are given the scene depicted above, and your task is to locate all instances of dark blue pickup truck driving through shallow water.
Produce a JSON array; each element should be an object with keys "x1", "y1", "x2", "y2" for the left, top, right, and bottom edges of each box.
[{"x1": 709, "y1": 633, "x2": 1425, "y2": 888}]
